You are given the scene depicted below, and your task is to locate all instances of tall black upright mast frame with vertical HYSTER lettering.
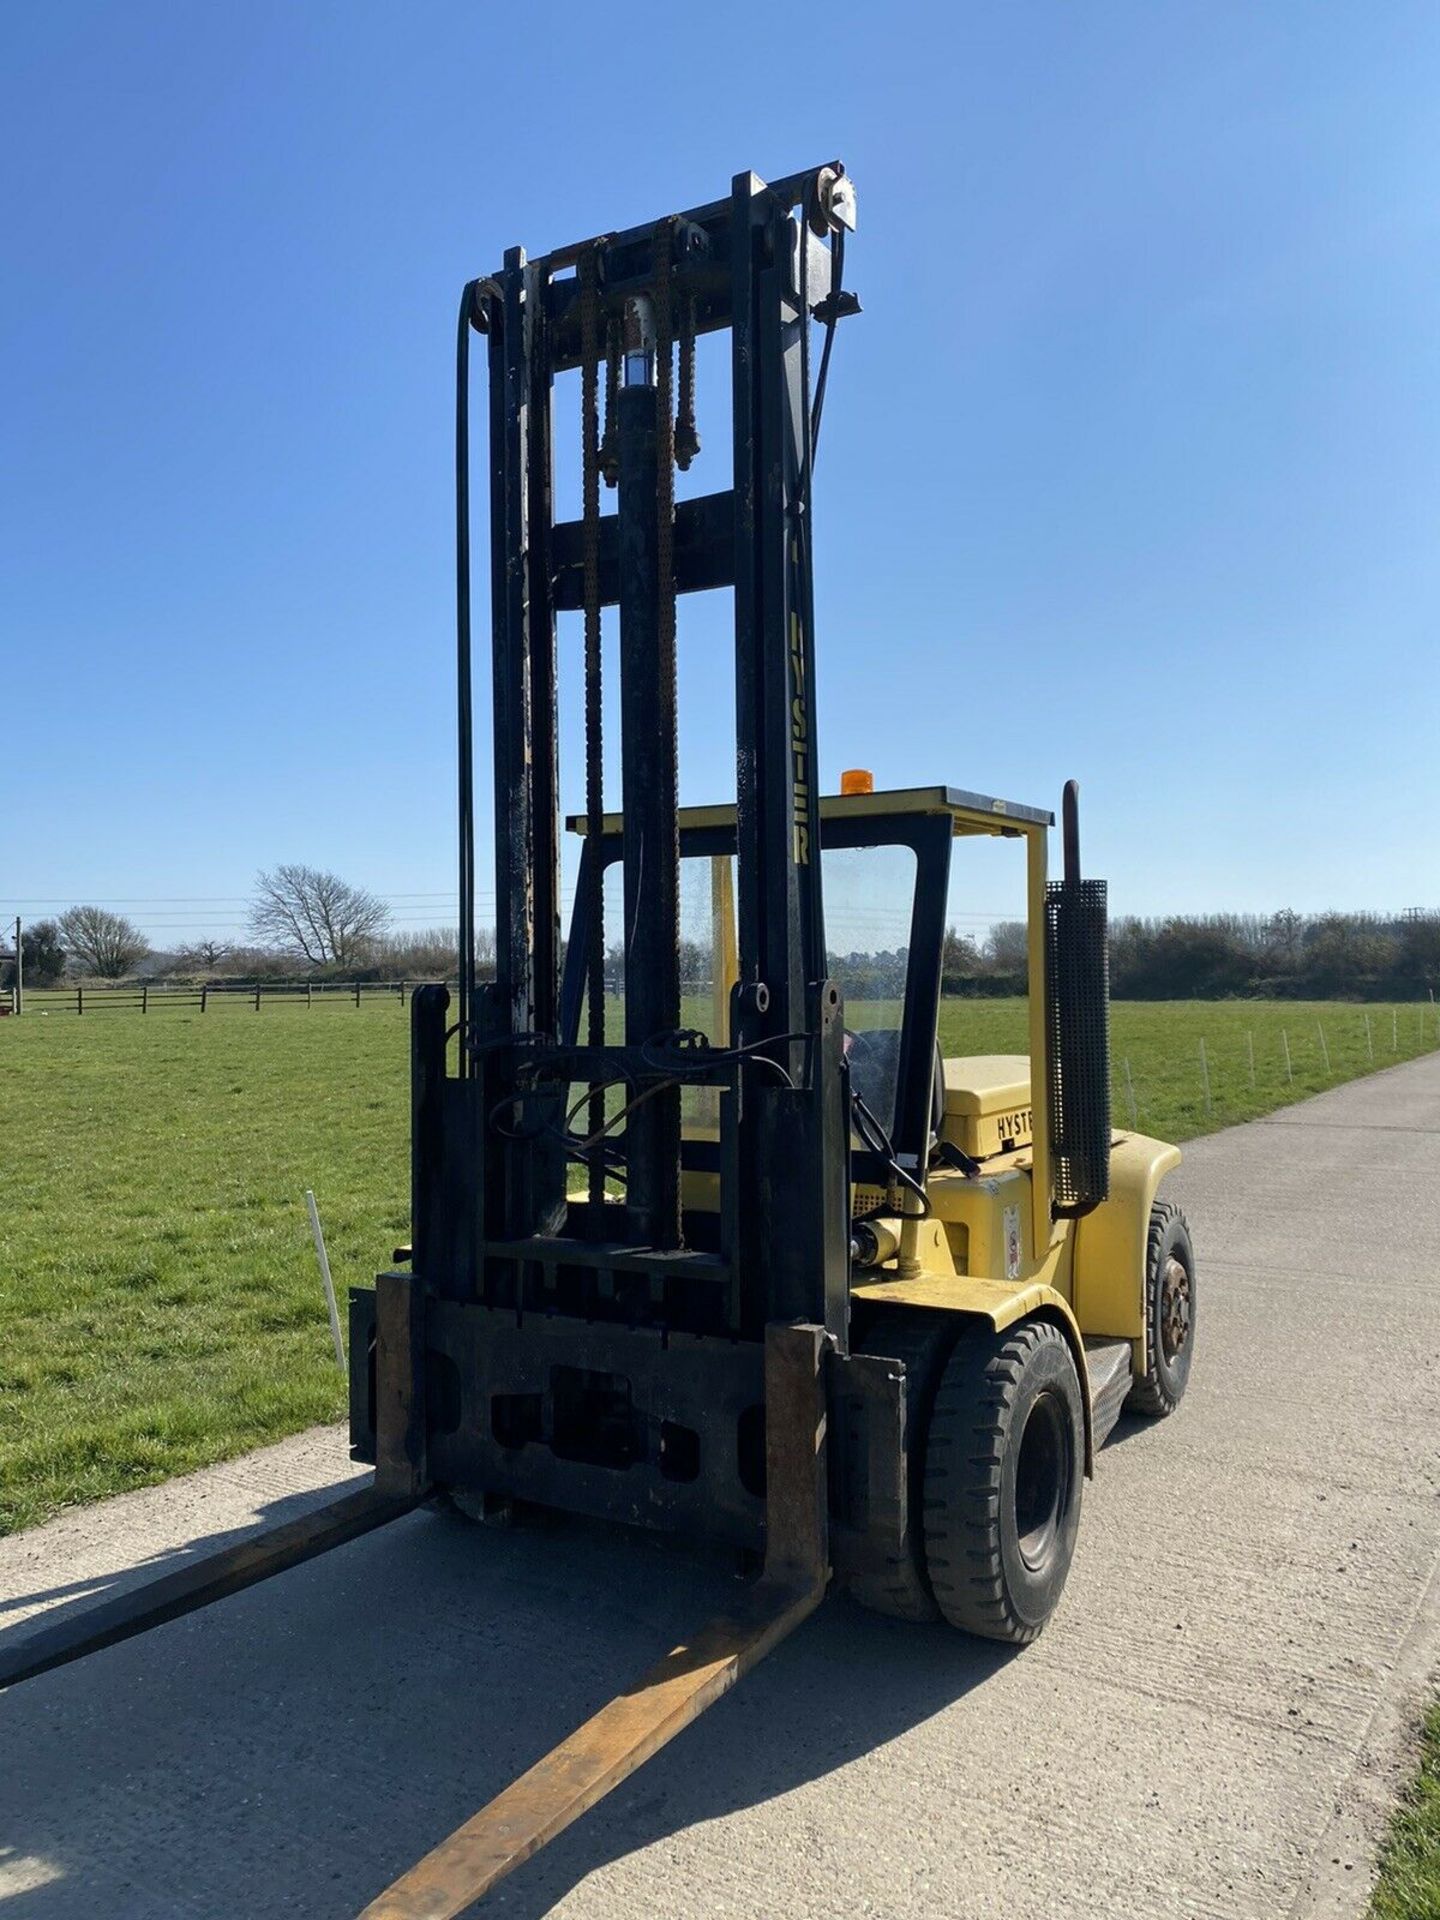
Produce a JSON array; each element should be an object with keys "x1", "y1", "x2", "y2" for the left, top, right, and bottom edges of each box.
[{"x1": 428, "y1": 167, "x2": 854, "y2": 1350}]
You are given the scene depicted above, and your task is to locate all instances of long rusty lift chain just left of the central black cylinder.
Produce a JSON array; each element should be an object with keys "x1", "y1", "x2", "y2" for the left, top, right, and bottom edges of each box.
[{"x1": 578, "y1": 240, "x2": 611, "y2": 1208}]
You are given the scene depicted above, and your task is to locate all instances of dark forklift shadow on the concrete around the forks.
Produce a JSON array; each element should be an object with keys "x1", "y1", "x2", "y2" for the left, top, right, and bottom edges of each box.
[{"x1": 0, "y1": 1503, "x2": 1010, "y2": 1920}]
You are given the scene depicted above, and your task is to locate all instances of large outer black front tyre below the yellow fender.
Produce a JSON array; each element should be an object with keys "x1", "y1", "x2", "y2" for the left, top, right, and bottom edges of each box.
[{"x1": 925, "y1": 1319, "x2": 1085, "y2": 1645}]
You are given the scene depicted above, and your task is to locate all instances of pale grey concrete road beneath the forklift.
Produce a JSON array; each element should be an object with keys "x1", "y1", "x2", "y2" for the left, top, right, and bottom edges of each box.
[{"x1": 0, "y1": 1058, "x2": 1440, "y2": 1920}]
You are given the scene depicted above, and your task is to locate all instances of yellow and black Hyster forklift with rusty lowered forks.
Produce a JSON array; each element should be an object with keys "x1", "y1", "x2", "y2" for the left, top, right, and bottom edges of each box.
[{"x1": 0, "y1": 161, "x2": 1196, "y2": 1920}]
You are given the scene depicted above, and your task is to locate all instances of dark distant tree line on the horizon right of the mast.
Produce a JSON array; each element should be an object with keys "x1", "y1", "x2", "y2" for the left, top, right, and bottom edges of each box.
[{"x1": 943, "y1": 908, "x2": 1440, "y2": 1000}]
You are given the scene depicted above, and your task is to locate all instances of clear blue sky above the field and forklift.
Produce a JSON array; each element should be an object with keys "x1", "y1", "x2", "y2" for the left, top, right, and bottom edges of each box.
[{"x1": 0, "y1": 0, "x2": 1440, "y2": 945}]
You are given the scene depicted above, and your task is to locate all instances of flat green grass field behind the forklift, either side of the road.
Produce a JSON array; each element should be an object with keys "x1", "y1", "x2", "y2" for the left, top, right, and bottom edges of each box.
[{"x1": 0, "y1": 1000, "x2": 1436, "y2": 1532}]
